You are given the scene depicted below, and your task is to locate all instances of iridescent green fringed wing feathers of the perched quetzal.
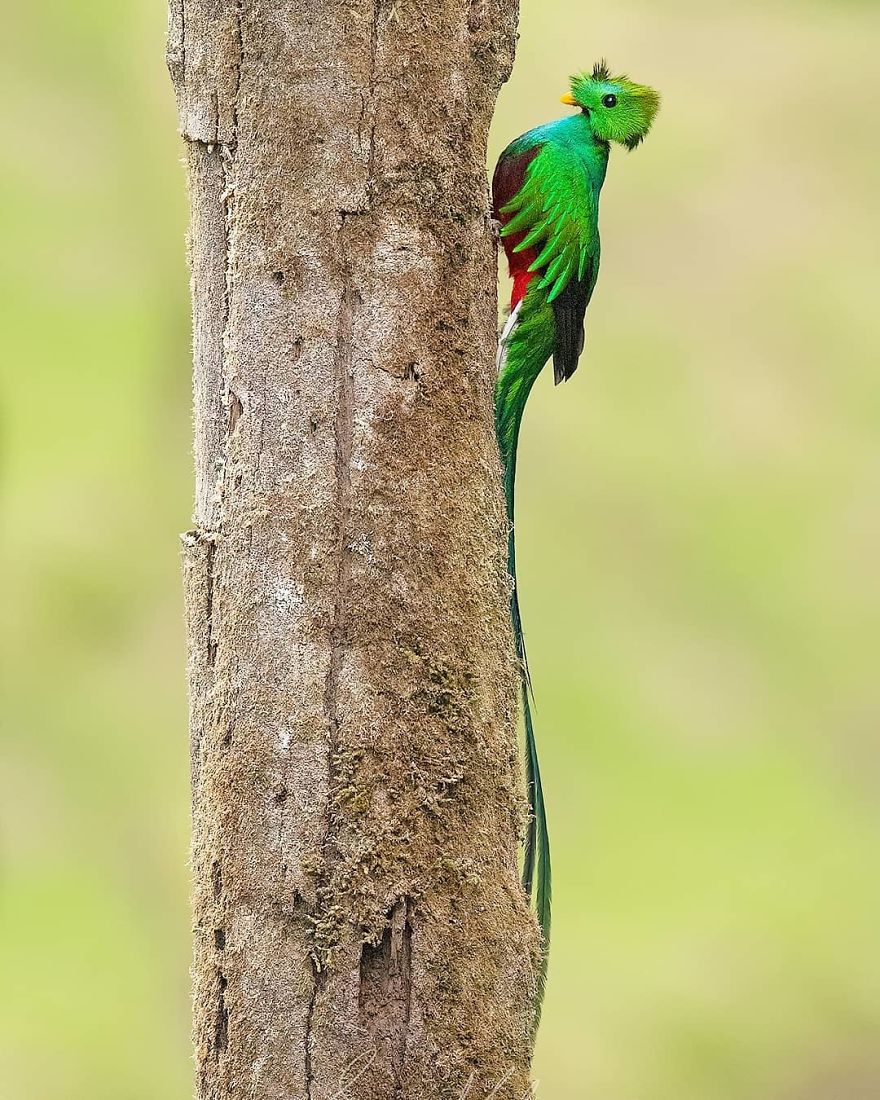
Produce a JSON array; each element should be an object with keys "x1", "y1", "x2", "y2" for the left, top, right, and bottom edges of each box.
[{"x1": 502, "y1": 142, "x2": 597, "y2": 301}]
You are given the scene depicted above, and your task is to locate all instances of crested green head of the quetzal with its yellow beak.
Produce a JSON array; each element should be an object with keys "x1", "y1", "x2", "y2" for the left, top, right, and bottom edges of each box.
[{"x1": 562, "y1": 62, "x2": 660, "y2": 149}]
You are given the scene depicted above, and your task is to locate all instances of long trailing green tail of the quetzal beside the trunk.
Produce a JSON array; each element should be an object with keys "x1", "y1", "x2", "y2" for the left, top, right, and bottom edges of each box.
[{"x1": 495, "y1": 293, "x2": 553, "y2": 1007}]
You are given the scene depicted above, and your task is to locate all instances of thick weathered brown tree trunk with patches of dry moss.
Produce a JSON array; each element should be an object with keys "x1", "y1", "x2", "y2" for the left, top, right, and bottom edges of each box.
[{"x1": 168, "y1": 0, "x2": 538, "y2": 1100}]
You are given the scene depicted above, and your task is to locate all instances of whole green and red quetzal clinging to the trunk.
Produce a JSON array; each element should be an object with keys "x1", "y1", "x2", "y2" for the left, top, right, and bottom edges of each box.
[{"x1": 492, "y1": 61, "x2": 660, "y2": 1015}]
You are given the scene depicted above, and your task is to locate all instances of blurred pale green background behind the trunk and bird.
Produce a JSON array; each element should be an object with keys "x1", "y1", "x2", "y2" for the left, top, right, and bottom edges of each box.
[{"x1": 0, "y1": 0, "x2": 880, "y2": 1100}]
